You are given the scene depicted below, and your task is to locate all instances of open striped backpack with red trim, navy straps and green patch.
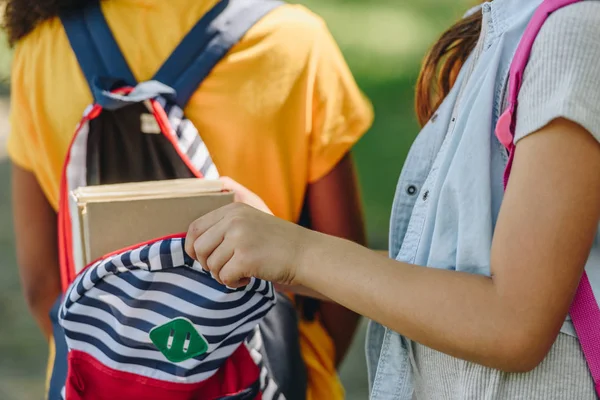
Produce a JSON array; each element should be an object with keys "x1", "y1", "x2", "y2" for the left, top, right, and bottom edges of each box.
[{"x1": 49, "y1": 0, "x2": 306, "y2": 400}]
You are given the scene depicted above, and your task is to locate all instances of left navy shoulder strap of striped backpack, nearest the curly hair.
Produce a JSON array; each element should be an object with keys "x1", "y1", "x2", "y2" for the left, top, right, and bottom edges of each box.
[{"x1": 60, "y1": 2, "x2": 136, "y2": 93}]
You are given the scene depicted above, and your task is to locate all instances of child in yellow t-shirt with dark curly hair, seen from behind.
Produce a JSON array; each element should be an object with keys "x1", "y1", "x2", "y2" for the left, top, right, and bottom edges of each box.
[{"x1": 4, "y1": 0, "x2": 372, "y2": 400}]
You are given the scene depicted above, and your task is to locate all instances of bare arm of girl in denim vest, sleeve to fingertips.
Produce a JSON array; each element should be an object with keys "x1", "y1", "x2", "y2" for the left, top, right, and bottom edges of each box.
[{"x1": 186, "y1": 120, "x2": 600, "y2": 372}]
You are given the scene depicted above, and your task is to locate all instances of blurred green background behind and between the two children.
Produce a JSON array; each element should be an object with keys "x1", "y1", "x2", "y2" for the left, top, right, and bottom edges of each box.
[{"x1": 0, "y1": 0, "x2": 473, "y2": 400}]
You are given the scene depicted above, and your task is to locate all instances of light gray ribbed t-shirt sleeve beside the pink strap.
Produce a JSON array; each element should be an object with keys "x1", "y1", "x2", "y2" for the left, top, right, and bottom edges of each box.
[{"x1": 515, "y1": 0, "x2": 600, "y2": 142}]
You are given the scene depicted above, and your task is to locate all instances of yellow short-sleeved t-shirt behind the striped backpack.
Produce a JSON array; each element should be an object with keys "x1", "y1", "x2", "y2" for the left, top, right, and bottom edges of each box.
[{"x1": 8, "y1": 0, "x2": 373, "y2": 400}]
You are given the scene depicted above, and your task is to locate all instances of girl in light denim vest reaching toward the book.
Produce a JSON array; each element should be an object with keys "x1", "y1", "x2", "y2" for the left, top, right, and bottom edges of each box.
[{"x1": 186, "y1": 0, "x2": 600, "y2": 400}]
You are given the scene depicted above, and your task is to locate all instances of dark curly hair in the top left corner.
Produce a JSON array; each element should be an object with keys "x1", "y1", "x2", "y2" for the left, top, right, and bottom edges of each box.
[{"x1": 0, "y1": 0, "x2": 97, "y2": 46}]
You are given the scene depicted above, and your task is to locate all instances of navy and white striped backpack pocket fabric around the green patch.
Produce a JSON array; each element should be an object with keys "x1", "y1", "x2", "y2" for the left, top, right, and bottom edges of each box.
[{"x1": 59, "y1": 238, "x2": 275, "y2": 384}]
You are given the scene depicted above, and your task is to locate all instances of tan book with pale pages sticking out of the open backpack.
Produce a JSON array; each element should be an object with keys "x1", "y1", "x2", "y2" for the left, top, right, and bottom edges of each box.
[{"x1": 69, "y1": 178, "x2": 233, "y2": 272}]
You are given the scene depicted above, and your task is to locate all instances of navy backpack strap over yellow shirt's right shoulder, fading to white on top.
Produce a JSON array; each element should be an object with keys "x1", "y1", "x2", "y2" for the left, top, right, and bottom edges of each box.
[{"x1": 154, "y1": 0, "x2": 283, "y2": 108}]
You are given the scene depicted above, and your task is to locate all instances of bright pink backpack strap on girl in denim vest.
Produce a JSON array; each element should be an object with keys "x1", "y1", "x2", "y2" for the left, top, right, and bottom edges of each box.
[{"x1": 496, "y1": 0, "x2": 600, "y2": 396}]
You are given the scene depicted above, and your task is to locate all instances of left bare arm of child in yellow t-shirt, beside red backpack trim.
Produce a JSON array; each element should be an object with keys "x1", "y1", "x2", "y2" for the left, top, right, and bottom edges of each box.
[{"x1": 12, "y1": 164, "x2": 60, "y2": 337}]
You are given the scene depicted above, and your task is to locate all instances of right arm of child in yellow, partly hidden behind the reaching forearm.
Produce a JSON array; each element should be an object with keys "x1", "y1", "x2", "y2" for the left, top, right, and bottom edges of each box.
[{"x1": 306, "y1": 154, "x2": 366, "y2": 366}]
